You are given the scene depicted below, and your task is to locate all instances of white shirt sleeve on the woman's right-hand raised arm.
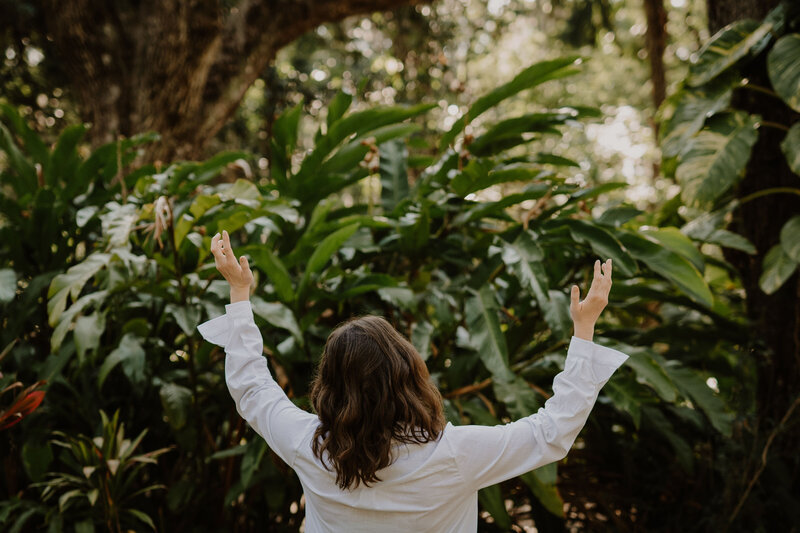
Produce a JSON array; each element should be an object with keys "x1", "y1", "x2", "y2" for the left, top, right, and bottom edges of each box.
[{"x1": 447, "y1": 337, "x2": 628, "y2": 491}]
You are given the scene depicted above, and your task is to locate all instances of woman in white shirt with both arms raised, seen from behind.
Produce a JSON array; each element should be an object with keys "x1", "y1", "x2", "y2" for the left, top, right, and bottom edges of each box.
[{"x1": 198, "y1": 232, "x2": 627, "y2": 533}]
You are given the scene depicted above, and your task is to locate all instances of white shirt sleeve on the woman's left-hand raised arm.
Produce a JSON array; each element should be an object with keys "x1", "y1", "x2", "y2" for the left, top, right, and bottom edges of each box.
[{"x1": 197, "y1": 300, "x2": 318, "y2": 466}]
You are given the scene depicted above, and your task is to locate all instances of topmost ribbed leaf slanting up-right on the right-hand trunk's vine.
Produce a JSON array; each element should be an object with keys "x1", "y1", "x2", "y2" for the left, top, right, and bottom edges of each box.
[{"x1": 688, "y1": 20, "x2": 772, "y2": 87}]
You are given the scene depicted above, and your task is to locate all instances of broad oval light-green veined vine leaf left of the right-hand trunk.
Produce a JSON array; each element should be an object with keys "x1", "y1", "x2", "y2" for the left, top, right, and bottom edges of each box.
[{"x1": 675, "y1": 111, "x2": 758, "y2": 206}]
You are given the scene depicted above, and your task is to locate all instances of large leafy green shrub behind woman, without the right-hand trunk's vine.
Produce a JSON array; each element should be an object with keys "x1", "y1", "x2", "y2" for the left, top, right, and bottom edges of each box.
[{"x1": 0, "y1": 57, "x2": 747, "y2": 531}]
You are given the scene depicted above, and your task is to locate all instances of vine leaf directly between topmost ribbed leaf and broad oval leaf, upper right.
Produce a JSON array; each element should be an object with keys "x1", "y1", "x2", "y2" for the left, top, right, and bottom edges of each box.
[{"x1": 659, "y1": 75, "x2": 738, "y2": 157}]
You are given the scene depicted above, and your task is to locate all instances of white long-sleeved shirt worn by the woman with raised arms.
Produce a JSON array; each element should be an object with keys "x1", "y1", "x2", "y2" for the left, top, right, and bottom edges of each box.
[{"x1": 198, "y1": 301, "x2": 628, "y2": 533}]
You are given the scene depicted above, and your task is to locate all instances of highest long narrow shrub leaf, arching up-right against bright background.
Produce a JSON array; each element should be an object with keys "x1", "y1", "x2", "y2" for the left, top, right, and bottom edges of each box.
[{"x1": 439, "y1": 56, "x2": 578, "y2": 151}]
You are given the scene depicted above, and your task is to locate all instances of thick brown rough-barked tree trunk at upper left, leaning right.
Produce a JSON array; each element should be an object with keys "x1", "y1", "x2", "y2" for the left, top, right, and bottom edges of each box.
[{"x1": 43, "y1": 0, "x2": 419, "y2": 161}]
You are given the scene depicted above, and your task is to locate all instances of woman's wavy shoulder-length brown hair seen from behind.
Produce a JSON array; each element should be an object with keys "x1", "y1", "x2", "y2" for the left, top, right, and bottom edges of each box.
[{"x1": 311, "y1": 316, "x2": 445, "y2": 489}]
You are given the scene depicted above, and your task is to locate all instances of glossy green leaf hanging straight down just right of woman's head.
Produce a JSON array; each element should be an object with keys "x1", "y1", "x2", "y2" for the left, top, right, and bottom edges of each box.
[{"x1": 466, "y1": 284, "x2": 514, "y2": 382}]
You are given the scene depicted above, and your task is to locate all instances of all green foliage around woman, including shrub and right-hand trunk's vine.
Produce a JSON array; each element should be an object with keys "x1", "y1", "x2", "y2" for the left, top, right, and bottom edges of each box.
[{"x1": 0, "y1": 0, "x2": 800, "y2": 532}]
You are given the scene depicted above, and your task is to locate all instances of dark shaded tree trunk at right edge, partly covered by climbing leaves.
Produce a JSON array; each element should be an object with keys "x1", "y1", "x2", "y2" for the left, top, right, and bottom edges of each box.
[{"x1": 708, "y1": 0, "x2": 800, "y2": 519}]
